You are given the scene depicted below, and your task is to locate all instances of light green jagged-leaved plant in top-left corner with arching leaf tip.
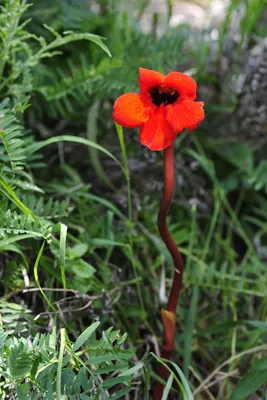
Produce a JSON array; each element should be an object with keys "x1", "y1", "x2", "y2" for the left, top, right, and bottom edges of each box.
[{"x1": 0, "y1": 0, "x2": 110, "y2": 112}]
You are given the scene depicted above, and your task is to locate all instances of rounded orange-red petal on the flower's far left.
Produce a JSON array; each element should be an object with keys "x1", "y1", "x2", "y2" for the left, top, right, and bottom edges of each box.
[{"x1": 113, "y1": 93, "x2": 152, "y2": 128}]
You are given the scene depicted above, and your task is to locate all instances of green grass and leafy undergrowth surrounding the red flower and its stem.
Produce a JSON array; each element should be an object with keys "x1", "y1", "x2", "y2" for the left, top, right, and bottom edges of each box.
[{"x1": 0, "y1": 0, "x2": 267, "y2": 400}]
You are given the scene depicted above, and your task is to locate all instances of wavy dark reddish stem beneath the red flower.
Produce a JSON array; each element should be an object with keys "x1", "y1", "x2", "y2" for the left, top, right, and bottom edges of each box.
[{"x1": 153, "y1": 145, "x2": 184, "y2": 400}]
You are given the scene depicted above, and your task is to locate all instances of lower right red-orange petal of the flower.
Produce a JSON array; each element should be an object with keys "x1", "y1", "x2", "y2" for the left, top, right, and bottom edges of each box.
[{"x1": 166, "y1": 101, "x2": 205, "y2": 133}]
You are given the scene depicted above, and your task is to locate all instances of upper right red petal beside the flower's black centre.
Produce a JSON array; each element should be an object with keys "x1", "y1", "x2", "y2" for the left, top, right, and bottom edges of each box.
[{"x1": 164, "y1": 72, "x2": 197, "y2": 100}]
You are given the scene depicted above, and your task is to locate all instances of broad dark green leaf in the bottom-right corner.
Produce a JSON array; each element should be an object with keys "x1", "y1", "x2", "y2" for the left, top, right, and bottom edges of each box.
[{"x1": 230, "y1": 357, "x2": 267, "y2": 400}]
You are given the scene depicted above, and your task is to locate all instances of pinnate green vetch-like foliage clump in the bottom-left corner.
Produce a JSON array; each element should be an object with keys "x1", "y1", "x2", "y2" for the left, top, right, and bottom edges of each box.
[{"x1": 0, "y1": 322, "x2": 138, "y2": 400}]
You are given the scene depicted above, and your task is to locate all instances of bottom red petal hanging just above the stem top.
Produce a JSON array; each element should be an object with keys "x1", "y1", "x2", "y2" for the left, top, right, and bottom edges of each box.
[{"x1": 140, "y1": 104, "x2": 176, "y2": 150}]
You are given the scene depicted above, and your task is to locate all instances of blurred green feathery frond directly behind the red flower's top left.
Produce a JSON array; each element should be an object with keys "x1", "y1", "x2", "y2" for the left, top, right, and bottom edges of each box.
[{"x1": 31, "y1": 27, "x2": 193, "y2": 118}]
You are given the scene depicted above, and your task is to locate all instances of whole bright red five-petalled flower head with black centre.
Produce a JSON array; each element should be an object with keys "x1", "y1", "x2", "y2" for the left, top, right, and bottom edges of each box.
[{"x1": 113, "y1": 68, "x2": 204, "y2": 150}]
